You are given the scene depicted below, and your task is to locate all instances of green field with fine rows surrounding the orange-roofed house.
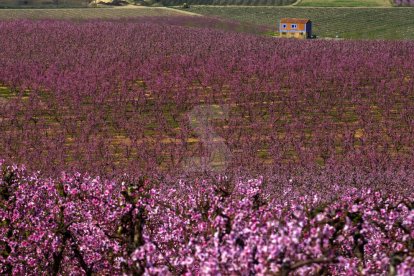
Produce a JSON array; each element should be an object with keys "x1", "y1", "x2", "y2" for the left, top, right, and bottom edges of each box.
[{"x1": 188, "y1": 6, "x2": 414, "y2": 39}]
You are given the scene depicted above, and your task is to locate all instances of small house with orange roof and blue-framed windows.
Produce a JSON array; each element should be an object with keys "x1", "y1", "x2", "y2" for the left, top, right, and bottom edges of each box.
[{"x1": 279, "y1": 18, "x2": 312, "y2": 39}]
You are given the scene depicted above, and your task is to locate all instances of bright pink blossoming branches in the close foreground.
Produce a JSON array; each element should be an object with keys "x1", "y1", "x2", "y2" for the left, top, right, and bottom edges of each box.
[{"x1": 0, "y1": 164, "x2": 414, "y2": 275}]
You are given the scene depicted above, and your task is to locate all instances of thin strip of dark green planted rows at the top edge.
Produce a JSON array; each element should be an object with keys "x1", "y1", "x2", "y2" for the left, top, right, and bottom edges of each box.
[{"x1": 160, "y1": 0, "x2": 296, "y2": 6}]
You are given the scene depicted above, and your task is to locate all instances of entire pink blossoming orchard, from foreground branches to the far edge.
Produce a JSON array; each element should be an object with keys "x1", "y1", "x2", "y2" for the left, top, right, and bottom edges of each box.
[{"x1": 0, "y1": 19, "x2": 414, "y2": 275}]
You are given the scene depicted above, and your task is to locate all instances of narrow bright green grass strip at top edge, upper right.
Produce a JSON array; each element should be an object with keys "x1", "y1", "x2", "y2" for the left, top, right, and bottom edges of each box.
[{"x1": 298, "y1": 0, "x2": 391, "y2": 7}]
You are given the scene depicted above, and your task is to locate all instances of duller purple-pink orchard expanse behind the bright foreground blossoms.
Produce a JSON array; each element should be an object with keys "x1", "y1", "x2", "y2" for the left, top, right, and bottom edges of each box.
[{"x1": 0, "y1": 18, "x2": 414, "y2": 176}]
